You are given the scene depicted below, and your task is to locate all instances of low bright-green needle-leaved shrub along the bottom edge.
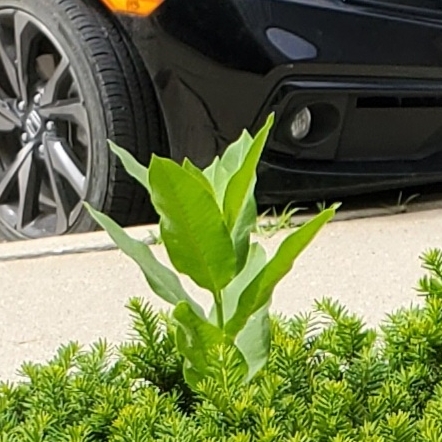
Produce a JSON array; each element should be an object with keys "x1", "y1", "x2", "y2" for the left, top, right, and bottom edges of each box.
[{"x1": 0, "y1": 250, "x2": 442, "y2": 442}]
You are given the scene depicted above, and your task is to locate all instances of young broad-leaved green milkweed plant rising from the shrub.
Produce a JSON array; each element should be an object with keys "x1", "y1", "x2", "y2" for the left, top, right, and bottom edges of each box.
[{"x1": 87, "y1": 115, "x2": 337, "y2": 390}]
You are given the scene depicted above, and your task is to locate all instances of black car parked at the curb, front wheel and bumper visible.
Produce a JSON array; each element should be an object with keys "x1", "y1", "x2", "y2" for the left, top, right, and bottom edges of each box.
[{"x1": 0, "y1": 0, "x2": 442, "y2": 238}]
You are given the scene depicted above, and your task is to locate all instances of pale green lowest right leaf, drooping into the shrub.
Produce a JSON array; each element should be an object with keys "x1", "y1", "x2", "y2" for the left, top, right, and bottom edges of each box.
[{"x1": 235, "y1": 302, "x2": 271, "y2": 382}]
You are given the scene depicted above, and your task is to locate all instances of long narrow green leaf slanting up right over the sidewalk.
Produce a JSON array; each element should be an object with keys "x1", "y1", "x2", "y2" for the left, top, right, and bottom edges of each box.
[{"x1": 225, "y1": 206, "x2": 338, "y2": 337}]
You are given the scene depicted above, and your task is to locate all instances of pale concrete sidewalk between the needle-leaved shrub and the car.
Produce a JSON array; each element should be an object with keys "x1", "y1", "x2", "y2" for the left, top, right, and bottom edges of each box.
[{"x1": 0, "y1": 210, "x2": 442, "y2": 379}]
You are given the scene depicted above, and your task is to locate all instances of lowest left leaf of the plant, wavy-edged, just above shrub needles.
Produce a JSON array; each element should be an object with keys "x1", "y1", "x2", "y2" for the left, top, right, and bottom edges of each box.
[{"x1": 173, "y1": 302, "x2": 246, "y2": 388}]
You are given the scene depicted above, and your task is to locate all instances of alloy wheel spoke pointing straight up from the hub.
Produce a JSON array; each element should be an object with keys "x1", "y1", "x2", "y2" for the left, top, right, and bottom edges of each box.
[{"x1": 14, "y1": 11, "x2": 35, "y2": 102}]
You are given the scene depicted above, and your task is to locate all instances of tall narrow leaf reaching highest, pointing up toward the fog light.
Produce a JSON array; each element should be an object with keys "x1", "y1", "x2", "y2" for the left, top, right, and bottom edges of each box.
[{"x1": 223, "y1": 114, "x2": 274, "y2": 271}]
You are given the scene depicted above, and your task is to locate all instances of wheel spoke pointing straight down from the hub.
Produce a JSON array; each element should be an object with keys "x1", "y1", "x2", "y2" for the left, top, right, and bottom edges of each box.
[{"x1": 16, "y1": 150, "x2": 40, "y2": 230}]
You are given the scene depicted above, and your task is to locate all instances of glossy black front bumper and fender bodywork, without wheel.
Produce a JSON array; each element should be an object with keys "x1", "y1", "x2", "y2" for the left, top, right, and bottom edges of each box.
[{"x1": 116, "y1": 0, "x2": 442, "y2": 202}]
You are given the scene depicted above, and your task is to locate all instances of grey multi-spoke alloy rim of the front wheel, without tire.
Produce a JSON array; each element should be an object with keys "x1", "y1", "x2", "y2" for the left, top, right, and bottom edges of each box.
[{"x1": 0, "y1": 8, "x2": 92, "y2": 238}]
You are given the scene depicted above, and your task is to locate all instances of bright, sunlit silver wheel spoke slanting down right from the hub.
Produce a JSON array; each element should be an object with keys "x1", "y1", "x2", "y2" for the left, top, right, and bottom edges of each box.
[{"x1": 45, "y1": 137, "x2": 86, "y2": 199}]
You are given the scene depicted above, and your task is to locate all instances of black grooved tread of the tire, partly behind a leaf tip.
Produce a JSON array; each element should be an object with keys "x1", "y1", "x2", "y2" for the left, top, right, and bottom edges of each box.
[{"x1": 55, "y1": 0, "x2": 161, "y2": 226}]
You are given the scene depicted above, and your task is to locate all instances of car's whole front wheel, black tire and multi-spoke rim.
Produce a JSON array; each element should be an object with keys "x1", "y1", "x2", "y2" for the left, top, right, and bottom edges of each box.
[{"x1": 0, "y1": 0, "x2": 158, "y2": 239}]
